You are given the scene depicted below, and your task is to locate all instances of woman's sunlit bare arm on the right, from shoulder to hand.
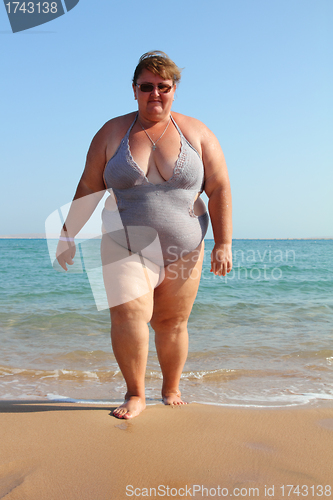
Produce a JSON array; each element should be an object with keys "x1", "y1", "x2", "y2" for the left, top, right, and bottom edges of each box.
[{"x1": 201, "y1": 127, "x2": 232, "y2": 276}]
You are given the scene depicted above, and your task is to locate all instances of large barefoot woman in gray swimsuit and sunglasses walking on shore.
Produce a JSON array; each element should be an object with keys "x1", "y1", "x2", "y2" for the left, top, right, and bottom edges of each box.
[{"x1": 57, "y1": 51, "x2": 232, "y2": 419}]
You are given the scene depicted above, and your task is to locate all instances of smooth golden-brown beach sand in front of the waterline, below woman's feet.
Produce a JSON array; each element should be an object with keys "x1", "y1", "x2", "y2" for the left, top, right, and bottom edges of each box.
[{"x1": 0, "y1": 401, "x2": 333, "y2": 500}]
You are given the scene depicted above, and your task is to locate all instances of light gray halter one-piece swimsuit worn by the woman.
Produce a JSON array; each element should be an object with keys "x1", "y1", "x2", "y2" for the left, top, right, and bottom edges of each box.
[{"x1": 102, "y1": 116, "x2": 209, "y2": 266}]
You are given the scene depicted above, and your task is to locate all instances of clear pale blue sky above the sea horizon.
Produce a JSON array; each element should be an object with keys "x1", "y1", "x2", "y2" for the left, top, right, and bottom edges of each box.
[{"x1": 0, "y1": 0, "x2": 333, "y2": 239}]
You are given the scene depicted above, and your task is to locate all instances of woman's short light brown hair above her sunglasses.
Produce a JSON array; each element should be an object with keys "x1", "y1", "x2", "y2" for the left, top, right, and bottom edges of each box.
[{"x1": 133, "y1": 50, "x2": 181, "y2": 85}]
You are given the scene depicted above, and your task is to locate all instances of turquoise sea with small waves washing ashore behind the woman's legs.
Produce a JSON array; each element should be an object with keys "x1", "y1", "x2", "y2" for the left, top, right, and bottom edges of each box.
[{"x1": 0, "y1": 239, "x2": 333, "y2": 407}]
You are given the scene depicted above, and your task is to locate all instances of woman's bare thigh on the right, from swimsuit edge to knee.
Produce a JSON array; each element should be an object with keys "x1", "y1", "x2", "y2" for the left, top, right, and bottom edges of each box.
[{"x1": 151, "y1": 242, "x2": 204, "y2": 328}]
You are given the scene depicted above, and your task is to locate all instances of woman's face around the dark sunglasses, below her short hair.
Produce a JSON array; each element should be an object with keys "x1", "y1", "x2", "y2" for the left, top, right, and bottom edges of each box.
[{"x1": 133, "y1": 69, "x2": 176, "y2": 121}]
